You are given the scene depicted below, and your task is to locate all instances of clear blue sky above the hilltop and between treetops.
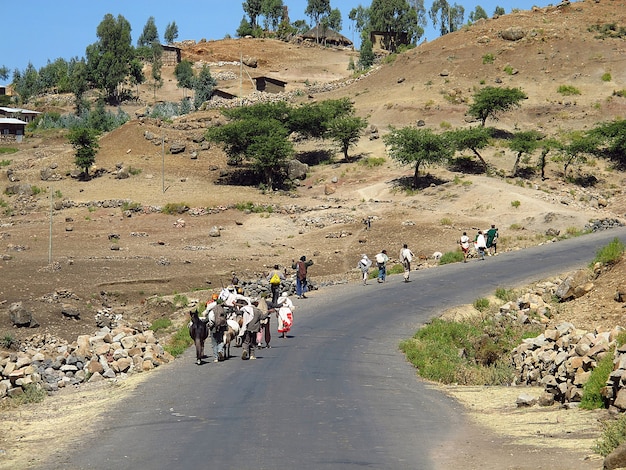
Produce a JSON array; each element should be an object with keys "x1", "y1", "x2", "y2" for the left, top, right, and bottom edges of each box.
[{"x1": 0, "y1": 0, "x2": 540, "y2": 74}]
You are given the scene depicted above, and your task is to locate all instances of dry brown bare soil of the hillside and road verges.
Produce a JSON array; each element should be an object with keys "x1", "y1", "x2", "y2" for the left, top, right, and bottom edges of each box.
[{"x1": 0, "y1": 1, "x2": 626, "y2": 469}]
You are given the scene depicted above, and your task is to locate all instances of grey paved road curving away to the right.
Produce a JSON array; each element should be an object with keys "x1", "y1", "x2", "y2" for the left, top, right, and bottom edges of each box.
[{"x1": 57, "y1": 229, "x2": 626, "y2": 470}]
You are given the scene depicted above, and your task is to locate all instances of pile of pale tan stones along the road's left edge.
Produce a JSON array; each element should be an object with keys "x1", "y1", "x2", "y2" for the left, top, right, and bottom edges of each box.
[{"x1": 0, "y1": 327, "x2": 174, "y2": 398}]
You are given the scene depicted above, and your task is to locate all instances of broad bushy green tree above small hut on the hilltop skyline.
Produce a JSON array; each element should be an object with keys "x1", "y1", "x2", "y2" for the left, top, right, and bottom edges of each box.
[{"x1": 369, "y1": 0, "x2": 417, "y2": 51}]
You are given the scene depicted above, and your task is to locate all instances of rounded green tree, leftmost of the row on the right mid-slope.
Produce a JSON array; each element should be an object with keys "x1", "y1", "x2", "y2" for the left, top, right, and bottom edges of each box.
[{"x1": 383, "y1": 127, "x2": 454, "y2": 188}]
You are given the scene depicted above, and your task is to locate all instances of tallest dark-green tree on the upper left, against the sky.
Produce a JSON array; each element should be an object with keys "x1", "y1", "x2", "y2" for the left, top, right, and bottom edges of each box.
[{"x1": 86, "y1": 13, "x2": 134, "y2": 101}]
